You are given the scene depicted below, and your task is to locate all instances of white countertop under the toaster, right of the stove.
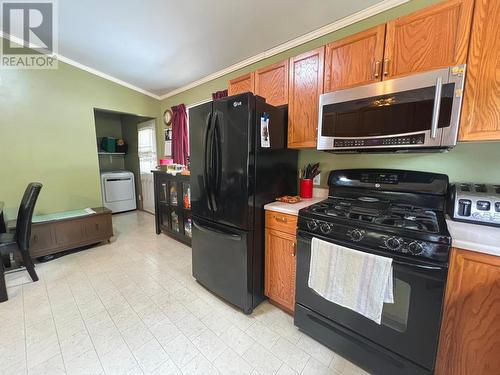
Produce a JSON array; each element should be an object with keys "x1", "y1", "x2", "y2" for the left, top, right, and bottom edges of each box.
[{"x1": 446, "y1": 219, "x2": 500, "y2": 256}]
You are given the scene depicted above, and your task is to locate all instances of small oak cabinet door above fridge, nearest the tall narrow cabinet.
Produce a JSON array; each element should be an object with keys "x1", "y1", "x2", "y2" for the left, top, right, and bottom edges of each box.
[{"x1": 255, "y1": 60, "x2": 288, "y2": 106}]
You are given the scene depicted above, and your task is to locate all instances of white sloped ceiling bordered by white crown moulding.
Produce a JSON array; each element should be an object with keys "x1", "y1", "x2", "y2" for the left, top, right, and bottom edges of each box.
[{"x1": 12, "y1": 0, "x2": 382, "y2": 95}]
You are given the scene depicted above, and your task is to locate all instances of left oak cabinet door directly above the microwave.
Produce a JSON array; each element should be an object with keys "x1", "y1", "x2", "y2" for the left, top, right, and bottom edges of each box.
[{"x1": 325, "y1": 24, "x2": 385, "y2": 92}]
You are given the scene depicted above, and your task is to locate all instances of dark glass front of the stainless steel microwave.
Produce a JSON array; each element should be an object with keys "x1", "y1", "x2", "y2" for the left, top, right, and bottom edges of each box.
[{"x1": 321, "y1": 83, "x2": 455, "y2": 138}]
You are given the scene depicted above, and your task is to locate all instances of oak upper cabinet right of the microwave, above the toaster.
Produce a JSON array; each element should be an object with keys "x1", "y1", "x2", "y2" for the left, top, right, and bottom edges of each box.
[{"x1": 460, "y1": 0, "x2": 500, "y2": 141}]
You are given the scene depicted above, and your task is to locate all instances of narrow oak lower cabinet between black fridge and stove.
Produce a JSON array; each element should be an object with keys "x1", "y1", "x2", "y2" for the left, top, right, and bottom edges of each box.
[{"x1": 264, "y1": 211, "x2": 297, "y2": 313}]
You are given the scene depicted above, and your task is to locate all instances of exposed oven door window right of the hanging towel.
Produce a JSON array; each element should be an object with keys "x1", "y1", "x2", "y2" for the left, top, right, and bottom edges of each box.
[{"x1": 382, "y1": 278, "x2": 411, "y2": 332}]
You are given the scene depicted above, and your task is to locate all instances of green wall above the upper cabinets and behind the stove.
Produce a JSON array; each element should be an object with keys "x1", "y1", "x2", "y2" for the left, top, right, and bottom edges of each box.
[{"x1": 159, "y1": 0, "x2": 500, "y2": 185}]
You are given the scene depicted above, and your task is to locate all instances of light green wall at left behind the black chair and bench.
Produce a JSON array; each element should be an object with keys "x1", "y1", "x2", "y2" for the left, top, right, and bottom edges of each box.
[{"x1": 0, "y1": 56, "x2": 159, "y2": 219}]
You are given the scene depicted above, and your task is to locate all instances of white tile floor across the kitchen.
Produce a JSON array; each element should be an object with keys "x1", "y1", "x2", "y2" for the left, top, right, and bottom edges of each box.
[{"x1": 0, "y1": 212, "x2": 365, "y2": 375}]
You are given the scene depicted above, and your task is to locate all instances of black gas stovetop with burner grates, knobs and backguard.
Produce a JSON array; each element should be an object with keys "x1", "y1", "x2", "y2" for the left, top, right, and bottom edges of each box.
[{"x1": 298, "y1": 170, "x2": 451, "y2": 263}]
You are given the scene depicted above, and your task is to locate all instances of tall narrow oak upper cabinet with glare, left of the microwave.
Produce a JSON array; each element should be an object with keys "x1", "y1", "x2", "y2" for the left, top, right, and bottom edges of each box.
[{"x1": 288, "y1": 47, "x2": 325, "y2": 148}]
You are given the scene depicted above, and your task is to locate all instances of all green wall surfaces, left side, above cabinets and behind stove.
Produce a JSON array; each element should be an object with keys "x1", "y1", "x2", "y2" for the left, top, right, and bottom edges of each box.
[{"x1": 0, "y1": 0, "x2": 500, "y2": 219}]
